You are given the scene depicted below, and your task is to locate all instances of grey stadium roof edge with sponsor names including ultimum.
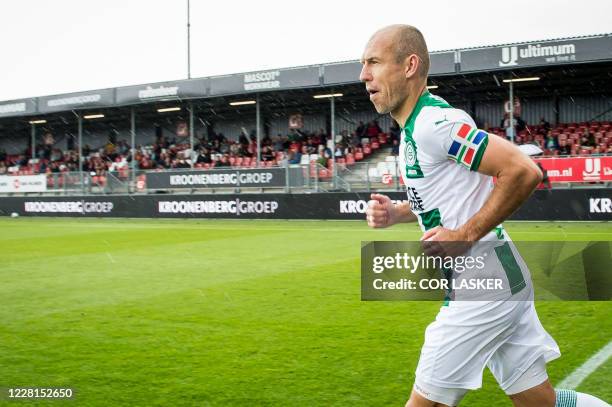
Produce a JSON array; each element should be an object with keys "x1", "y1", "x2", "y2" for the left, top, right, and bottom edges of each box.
[{"x1": 0, "y1": 34, "x2": 612, "y2": 118}]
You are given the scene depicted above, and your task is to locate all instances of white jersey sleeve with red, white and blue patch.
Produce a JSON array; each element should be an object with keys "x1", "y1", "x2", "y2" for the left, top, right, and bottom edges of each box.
[{"x1": 416, "y1": 109, "x2": 489, "y2": 171}]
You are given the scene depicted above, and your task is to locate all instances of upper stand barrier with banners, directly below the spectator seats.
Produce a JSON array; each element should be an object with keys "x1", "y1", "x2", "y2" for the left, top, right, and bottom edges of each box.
[{"x1": 0, "y1": 156, "x2": 612, "y2": 196}]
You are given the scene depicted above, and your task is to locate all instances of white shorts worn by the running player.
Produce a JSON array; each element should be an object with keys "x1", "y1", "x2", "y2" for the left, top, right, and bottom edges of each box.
[{"x1": 414, "y1": 300, "x2": 561, "y2": 406}]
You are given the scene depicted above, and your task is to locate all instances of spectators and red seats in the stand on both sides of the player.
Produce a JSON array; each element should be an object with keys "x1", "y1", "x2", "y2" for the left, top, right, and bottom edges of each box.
[{"x1": 0, "y1": 116, "x2": 612, "y2": 176}]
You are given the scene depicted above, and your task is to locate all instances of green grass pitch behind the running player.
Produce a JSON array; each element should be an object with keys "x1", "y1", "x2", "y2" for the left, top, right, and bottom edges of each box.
[{"x1": 0, "y1": 218, "x2": 612, "y2": 407}]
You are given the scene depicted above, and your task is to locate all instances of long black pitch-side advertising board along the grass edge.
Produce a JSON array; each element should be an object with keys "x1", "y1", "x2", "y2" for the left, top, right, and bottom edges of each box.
[{"x1": 0, "y1": 188, "x2": 612, "y2": 221}]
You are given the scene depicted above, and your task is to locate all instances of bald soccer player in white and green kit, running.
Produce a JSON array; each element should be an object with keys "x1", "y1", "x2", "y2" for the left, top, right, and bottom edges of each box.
[{"x1": 360, "y1": 25, "x2": 608, "y2": 407}]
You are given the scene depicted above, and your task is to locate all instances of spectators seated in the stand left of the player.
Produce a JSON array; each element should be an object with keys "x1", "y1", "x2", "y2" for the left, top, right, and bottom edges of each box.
[{"x1": 0, "y1": 120, "x2": 383, "y2": 176}]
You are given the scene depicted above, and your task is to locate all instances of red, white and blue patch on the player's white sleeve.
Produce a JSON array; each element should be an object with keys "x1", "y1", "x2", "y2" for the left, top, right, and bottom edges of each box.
[{"x1": 448, "y1": 123, "x2": 489, "y2": 171}]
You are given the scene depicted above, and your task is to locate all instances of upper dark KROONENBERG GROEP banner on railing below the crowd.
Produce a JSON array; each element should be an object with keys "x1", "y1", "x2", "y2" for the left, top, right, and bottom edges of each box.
[{"x1": 146, "y1": 168, "x2": 287, "y2": 190}]
